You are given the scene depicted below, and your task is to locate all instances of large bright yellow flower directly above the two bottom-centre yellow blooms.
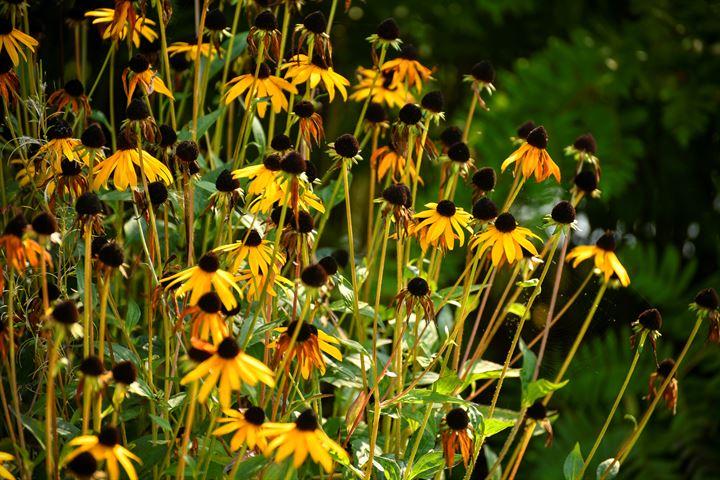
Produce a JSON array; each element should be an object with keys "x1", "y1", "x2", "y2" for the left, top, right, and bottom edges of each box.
[{"x1": 180, "y1": 337, "x2": 275, "y2": 409}]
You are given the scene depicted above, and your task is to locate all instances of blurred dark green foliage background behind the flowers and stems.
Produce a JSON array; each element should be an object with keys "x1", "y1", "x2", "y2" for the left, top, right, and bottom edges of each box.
[{"x1": 31, "y1": 0, "x2": 720, "y2": 480}]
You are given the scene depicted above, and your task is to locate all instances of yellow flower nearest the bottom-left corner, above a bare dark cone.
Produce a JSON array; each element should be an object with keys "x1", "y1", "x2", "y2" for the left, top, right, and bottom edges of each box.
[{"x1": 65, "y1": 426, "x2": 142, "y2": 480}]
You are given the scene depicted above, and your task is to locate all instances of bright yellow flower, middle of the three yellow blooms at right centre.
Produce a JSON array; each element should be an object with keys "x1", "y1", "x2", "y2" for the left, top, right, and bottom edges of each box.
[{"x1": 470, "y1": 212, "x2": 540, "y2": 267}]
